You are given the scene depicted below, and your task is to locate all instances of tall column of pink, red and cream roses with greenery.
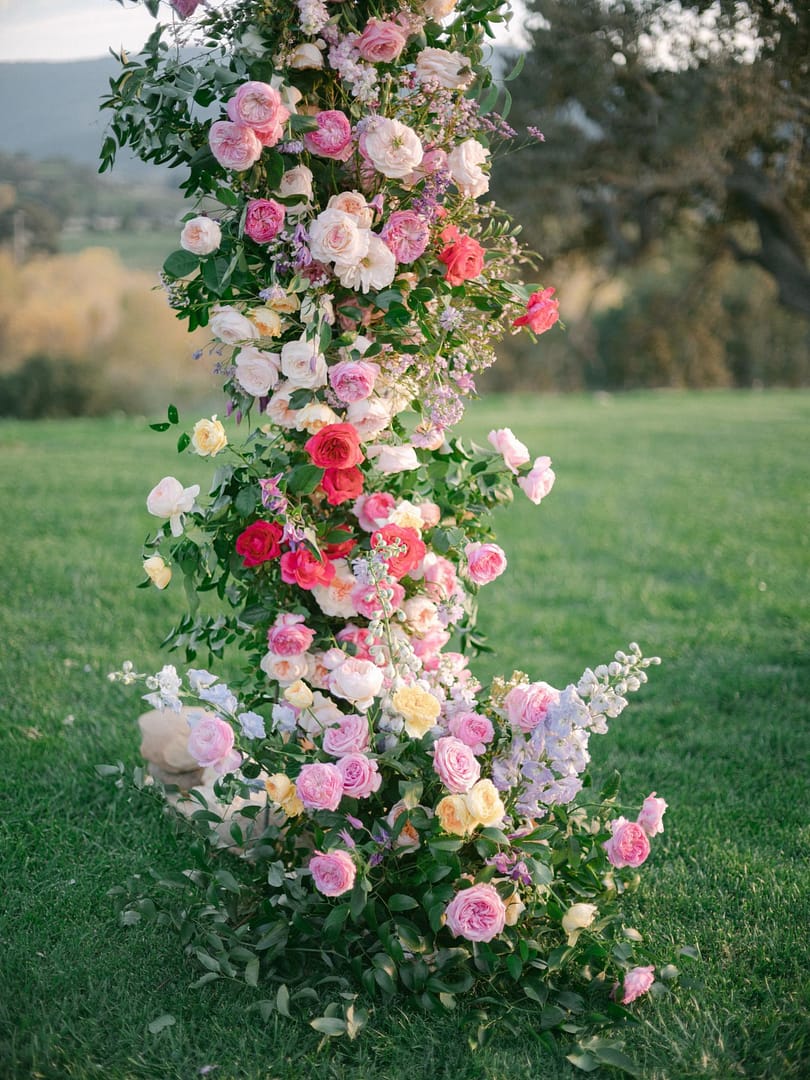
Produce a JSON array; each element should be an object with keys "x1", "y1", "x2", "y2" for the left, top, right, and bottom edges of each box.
[{"x1": 103, "y1": 0, "x2": 666, "y2": 1054}]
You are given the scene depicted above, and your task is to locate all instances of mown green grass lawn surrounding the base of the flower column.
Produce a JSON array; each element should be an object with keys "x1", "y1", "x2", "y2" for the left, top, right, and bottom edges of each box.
[{"x1": 0, "y1": 392, "x2": 810, "y2": 1080}]
